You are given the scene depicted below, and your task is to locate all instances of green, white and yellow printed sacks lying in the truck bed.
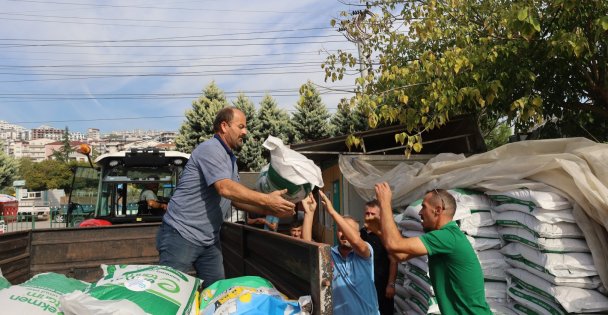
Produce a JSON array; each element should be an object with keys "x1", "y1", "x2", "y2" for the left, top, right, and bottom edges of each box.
[{"x1": 0, "y1": 265, "x2": 312, "y2": 315}]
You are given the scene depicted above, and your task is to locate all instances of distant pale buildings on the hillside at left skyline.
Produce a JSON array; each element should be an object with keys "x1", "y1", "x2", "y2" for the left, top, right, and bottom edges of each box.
[{"x1": 0, "y1": 120, "x2": 176, "y2": 162}]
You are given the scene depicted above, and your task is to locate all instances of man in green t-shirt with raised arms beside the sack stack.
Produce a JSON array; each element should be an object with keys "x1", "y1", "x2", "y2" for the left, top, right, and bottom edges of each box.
[{"x1": 367, "y1": 183, "x2": 492, "y2": 314}]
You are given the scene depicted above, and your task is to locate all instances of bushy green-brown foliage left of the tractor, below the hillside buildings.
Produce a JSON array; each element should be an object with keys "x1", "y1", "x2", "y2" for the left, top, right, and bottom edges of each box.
[{"x1": 19, "y1": 158, "x2": 72, "y2": 191}]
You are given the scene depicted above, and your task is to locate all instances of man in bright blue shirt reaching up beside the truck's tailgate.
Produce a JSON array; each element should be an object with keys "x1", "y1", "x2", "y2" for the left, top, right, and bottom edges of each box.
[{"x1": 319, "y1": 190, "x2": 380, "y2": 315}]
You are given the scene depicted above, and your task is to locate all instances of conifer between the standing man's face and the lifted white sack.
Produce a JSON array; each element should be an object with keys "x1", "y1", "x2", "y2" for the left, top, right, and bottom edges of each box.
[{"x1": 233, "y1": 93, "x2": 268, "y2": 172}]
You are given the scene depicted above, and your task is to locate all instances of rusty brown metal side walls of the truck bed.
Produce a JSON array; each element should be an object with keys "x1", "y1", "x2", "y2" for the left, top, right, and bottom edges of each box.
[{"x1": 0, "y1": 222, "x2": 332, "y2": 314}]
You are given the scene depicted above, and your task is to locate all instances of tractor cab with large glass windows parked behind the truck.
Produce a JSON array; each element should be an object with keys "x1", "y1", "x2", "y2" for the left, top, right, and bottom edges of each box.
[{"x1": 67, "y1": 148, "x2": 189, "y2": 226}]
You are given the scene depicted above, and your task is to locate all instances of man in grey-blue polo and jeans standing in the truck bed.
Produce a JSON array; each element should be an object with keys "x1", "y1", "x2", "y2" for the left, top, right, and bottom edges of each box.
[{"x1": 156, "y1": 107, "x2": 295, "y2": 287}]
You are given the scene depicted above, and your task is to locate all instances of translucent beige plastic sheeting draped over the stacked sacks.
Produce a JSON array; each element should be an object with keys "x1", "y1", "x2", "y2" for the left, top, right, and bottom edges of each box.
[{"x1": 339, "y1": 138, "x2": 608, "y2": 289}]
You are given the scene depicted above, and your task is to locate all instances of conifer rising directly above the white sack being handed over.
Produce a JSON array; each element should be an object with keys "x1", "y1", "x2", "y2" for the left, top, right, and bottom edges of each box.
[{"x1": 258, "y1": 94, "x2": 296, "y2": 144}]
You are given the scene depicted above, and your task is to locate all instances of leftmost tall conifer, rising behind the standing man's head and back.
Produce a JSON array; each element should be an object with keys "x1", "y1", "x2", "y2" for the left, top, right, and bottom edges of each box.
[{"x1": 175, "y1": 81, "x2": 229, "y2": 153}]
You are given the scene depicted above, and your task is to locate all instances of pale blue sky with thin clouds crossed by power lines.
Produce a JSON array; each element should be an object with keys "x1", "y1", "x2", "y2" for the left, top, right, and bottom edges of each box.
[{"x1": 0, "y1": 0, "x2": 361, "y2": 133}]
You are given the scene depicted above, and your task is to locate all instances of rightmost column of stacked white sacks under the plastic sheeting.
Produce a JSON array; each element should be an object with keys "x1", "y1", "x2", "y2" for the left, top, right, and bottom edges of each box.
[{"x1": 486, "y1": 188, "x2": 608, "y2": 314}]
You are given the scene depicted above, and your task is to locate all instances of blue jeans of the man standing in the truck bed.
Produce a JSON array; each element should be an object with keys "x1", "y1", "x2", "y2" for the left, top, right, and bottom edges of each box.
[{"x1": 156, "y1": 222, "x2": 225, "y2": 288}]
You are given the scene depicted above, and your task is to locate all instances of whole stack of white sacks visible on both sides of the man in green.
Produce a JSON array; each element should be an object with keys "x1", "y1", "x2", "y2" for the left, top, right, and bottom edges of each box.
[{"x1": 395, "y1": 189, "x2": 608, "y2": 315}]
